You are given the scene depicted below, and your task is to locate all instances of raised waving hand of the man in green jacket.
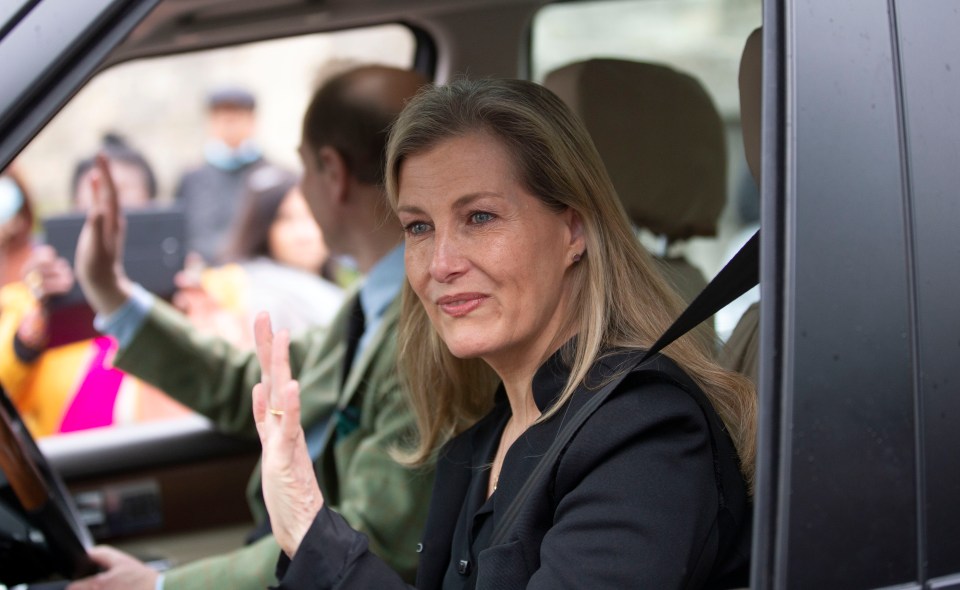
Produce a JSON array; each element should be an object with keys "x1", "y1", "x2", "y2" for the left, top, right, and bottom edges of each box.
[{"x1": 74, "y1": 154, "x2": 130, "y2": 314}]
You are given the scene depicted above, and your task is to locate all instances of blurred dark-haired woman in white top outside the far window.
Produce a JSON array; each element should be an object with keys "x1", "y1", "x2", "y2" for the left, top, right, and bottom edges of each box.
[{"x1": 176, "y1": 166, "x2": 344, "y2": 348}]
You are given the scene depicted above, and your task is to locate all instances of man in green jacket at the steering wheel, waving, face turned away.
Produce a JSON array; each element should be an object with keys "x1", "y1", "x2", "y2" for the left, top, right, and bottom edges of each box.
[{"x1": 70, "y1": 66, "x2": 433, "y2": 590}]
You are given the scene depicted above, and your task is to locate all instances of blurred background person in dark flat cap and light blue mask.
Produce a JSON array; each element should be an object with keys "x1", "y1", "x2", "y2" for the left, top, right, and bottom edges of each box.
[{"x1": 176, "y1": 87, "x2": 267, "y2": 262}]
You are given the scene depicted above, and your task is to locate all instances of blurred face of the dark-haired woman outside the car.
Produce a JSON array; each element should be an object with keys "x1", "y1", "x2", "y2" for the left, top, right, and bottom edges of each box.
[{"x1": 267, "y1": 186, "x2": 327, "y2": 273}]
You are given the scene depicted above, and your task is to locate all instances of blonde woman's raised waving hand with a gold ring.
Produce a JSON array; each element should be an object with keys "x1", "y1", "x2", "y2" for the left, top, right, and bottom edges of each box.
[{"x1": 253, "y1": 313, "x2": 323, "y2": 558}]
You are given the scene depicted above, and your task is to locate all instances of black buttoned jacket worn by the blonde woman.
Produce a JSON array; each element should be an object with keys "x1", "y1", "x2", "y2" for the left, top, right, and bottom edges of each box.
[{"x1": 278, "y1": 352, "x2": 751, "y2": 590}]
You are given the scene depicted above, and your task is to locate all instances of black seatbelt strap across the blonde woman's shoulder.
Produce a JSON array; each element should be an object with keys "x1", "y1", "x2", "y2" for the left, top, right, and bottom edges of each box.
[{"x1": 490, "y1": 230, "x2": 760, "y2": 547}]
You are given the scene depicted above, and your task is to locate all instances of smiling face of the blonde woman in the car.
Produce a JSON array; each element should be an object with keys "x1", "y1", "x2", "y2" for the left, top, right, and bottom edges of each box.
[{"x1": 398, "y1": 133, "x2": 584, "y2": 375}]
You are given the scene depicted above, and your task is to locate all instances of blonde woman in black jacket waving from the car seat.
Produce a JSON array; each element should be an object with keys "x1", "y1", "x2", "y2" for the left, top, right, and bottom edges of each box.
[{"x1": 254, "y1": 81, "x2": 756, "y2": 589}]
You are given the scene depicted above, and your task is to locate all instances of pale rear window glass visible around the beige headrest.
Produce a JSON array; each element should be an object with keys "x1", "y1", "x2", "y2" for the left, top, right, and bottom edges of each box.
[{"x1": 531, "y1": 0, "x2": 761, "y2": 337}]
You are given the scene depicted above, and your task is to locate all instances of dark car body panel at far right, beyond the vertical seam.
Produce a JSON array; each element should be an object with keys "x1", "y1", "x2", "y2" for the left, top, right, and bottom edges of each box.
[{"x1": 896, "y1": 2, "x2": 960, "y2": 587}]
